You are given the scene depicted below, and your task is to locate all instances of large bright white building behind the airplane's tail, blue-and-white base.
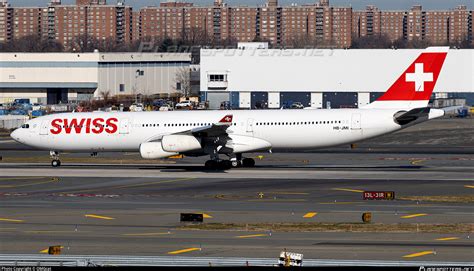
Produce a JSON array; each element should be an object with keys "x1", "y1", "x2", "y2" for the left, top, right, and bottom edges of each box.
[{"x1": 201, "y1": 46, "x2": 474, "y2": 108}]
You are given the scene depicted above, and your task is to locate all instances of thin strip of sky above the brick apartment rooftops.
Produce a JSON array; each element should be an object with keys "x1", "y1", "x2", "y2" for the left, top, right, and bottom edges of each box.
[{"x1": 8, "y1": 0, "x2": 474, "y2": 10}]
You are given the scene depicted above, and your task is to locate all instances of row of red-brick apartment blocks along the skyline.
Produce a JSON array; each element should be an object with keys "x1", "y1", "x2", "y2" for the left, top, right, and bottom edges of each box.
[{"x1": 0, "y1": 0, "x2": 474, "y2": 48}]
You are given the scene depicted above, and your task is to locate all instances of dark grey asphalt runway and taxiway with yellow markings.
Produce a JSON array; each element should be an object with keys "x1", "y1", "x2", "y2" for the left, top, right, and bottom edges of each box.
[{"x1": 0, "y1": 120, "x2": 474, "y2": 261}]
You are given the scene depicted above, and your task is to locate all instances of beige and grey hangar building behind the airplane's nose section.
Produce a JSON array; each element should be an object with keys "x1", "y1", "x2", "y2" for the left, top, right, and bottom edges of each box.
[{"x1": 0, "y1": 52, "x2": 191, "y2": 104}]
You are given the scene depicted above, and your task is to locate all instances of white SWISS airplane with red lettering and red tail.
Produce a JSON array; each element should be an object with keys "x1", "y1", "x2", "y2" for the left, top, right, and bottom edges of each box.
[{"x1": 11, "y1": 47, "x2": 449, "y2": 170}]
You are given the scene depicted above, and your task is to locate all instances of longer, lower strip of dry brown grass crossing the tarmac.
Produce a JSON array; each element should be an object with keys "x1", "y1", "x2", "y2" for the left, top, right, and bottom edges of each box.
[{"x1": 179, "y1": 223, "x2": 474, "y2": 233}]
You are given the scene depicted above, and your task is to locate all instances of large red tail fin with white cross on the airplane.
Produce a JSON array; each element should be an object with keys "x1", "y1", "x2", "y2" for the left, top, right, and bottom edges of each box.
[{"x1": 367, "y1": 47, "x2": 449, "y2": 108}]
